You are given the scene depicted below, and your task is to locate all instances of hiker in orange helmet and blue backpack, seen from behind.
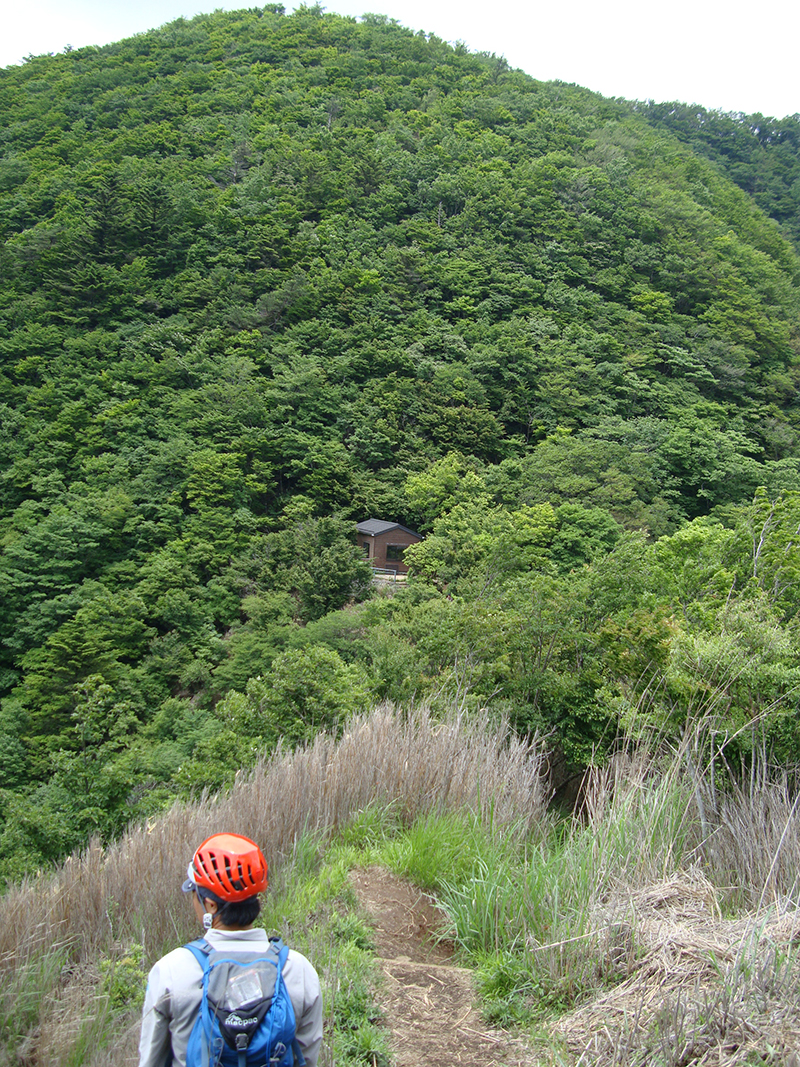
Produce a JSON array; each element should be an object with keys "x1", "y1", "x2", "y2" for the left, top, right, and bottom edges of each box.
[{"x1": 139, "y1": 833, "x2": 322, "y2": 1067}]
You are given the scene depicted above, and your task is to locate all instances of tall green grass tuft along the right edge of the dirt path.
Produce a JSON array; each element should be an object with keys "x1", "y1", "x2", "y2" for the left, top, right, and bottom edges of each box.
[{"x1": 439, "y1": 753, "x2": 695, "y2": 1021}]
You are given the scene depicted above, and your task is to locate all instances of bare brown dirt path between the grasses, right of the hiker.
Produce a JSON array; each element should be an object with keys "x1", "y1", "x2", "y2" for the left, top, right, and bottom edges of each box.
[{"x1": 351, "y1": 867, "x2": 537, "y2": 1067}]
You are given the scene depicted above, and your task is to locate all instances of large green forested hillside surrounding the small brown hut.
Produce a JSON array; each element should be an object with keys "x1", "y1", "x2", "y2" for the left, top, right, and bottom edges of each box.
[{"x1": 0, "y1": 4, "x2": 800, "y2": 877}]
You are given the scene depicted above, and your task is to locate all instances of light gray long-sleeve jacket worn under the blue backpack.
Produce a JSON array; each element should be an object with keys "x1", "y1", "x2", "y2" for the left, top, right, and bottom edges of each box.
[{"x1": 139, "y1": 929, "x2": 322, "y2": 1067}]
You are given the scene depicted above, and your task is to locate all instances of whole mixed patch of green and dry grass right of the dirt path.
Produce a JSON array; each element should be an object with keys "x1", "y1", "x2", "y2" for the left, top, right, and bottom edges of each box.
[{"x1": 428, "y1": 724, "x2": 800, "y2": 1067}]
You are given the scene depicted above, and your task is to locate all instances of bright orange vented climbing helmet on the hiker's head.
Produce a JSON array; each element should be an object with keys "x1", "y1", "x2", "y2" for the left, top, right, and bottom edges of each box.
[{"x1": 181, "y1": 833, "x2": 267, "y2": 904}]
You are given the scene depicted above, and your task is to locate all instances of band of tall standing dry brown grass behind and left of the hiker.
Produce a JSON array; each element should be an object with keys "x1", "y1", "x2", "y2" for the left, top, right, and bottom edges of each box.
[{"x1": 0, "y1": 706, "x2": 547, "y2": 1067}]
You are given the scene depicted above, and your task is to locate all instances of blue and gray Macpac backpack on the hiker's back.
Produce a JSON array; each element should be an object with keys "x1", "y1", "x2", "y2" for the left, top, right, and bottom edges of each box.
[{"x1": 183, "y1": 938, "x2": 305, "y2": 1067}]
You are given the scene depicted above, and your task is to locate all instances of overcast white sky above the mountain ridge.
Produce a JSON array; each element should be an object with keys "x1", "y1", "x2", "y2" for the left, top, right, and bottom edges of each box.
[{"x1": 0, "y1": 0, "x2": 800, "y2": 117}]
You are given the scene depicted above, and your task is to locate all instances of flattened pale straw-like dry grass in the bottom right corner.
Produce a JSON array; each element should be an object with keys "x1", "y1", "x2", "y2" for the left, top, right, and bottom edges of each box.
[{"x1": 553, "y1": 869, "x2": 800, "y2": 1067}]
